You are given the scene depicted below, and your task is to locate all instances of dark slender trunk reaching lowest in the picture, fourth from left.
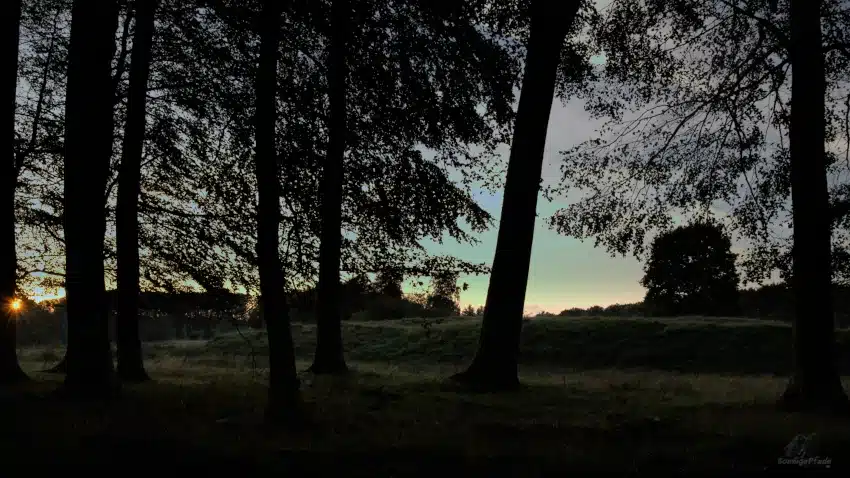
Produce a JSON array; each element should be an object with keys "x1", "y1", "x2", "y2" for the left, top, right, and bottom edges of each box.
[{"x1": 254, "y1": 0, "x2": 304, "y2": 427}]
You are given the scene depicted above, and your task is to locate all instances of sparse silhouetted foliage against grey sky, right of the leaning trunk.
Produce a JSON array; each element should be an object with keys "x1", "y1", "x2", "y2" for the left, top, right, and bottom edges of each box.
[{"x1": 548, "y1": 0, "x2": 850, "y2": 283}]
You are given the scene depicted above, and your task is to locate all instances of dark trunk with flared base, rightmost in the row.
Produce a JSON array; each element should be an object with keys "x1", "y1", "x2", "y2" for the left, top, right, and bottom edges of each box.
[{"x1": 780, "y1": 0, "x2": 850, "y2": 413}]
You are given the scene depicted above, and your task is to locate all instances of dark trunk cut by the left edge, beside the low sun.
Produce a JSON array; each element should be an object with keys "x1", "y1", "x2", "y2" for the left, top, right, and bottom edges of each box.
[{"x1": 0, "y1": 0, "x2": 26, "y2": 383}]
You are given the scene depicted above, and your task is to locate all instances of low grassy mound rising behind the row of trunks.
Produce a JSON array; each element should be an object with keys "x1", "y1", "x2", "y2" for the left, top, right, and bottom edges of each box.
[{"x1": 149, "y1": 318, "x2": 850, "y2": 375}]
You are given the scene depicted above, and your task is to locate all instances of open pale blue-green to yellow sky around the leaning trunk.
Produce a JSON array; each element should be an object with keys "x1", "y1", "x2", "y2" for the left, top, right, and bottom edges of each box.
[{"x1": 414, "y1": 98, "x2": 645, "y2": 314}]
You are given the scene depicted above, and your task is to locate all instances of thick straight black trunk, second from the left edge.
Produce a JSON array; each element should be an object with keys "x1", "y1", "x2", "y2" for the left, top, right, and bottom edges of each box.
[{"x1": 64, "y1": 0, "x2": 118, "y2": 398}]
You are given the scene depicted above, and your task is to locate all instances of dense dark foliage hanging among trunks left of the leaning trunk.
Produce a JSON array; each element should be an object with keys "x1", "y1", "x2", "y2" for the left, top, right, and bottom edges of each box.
[{"x1": 17, "y1": 0, "x2": 519, "y2": 292}]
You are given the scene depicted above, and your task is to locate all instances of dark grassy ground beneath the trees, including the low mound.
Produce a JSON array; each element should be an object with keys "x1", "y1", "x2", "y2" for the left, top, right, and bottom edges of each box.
[{"x1": 0, "y1": 318, "x2": 850, "y2": 476}]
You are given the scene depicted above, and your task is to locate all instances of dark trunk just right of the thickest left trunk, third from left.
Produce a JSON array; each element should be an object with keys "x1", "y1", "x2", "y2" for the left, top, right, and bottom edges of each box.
[{"x1": 115, "y1": 0, "x2": 157, "y2": 382}]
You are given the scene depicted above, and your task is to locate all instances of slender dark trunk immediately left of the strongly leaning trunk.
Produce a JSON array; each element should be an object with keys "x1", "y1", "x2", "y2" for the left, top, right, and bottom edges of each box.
[{"x1": 310, "y1": 0, "x2": 348, "y2": 374}]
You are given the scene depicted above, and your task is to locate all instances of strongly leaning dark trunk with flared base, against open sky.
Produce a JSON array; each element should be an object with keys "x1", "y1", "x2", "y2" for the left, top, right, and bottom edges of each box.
[{"x1": 452, "y1": 0, "x2": 580, "y2": 391}]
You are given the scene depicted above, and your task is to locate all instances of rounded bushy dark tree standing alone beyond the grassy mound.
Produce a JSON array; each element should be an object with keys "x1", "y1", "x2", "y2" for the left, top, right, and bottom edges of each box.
[{"x1": 640, "y1": 222, "x2": 739, "y2": 316}]
